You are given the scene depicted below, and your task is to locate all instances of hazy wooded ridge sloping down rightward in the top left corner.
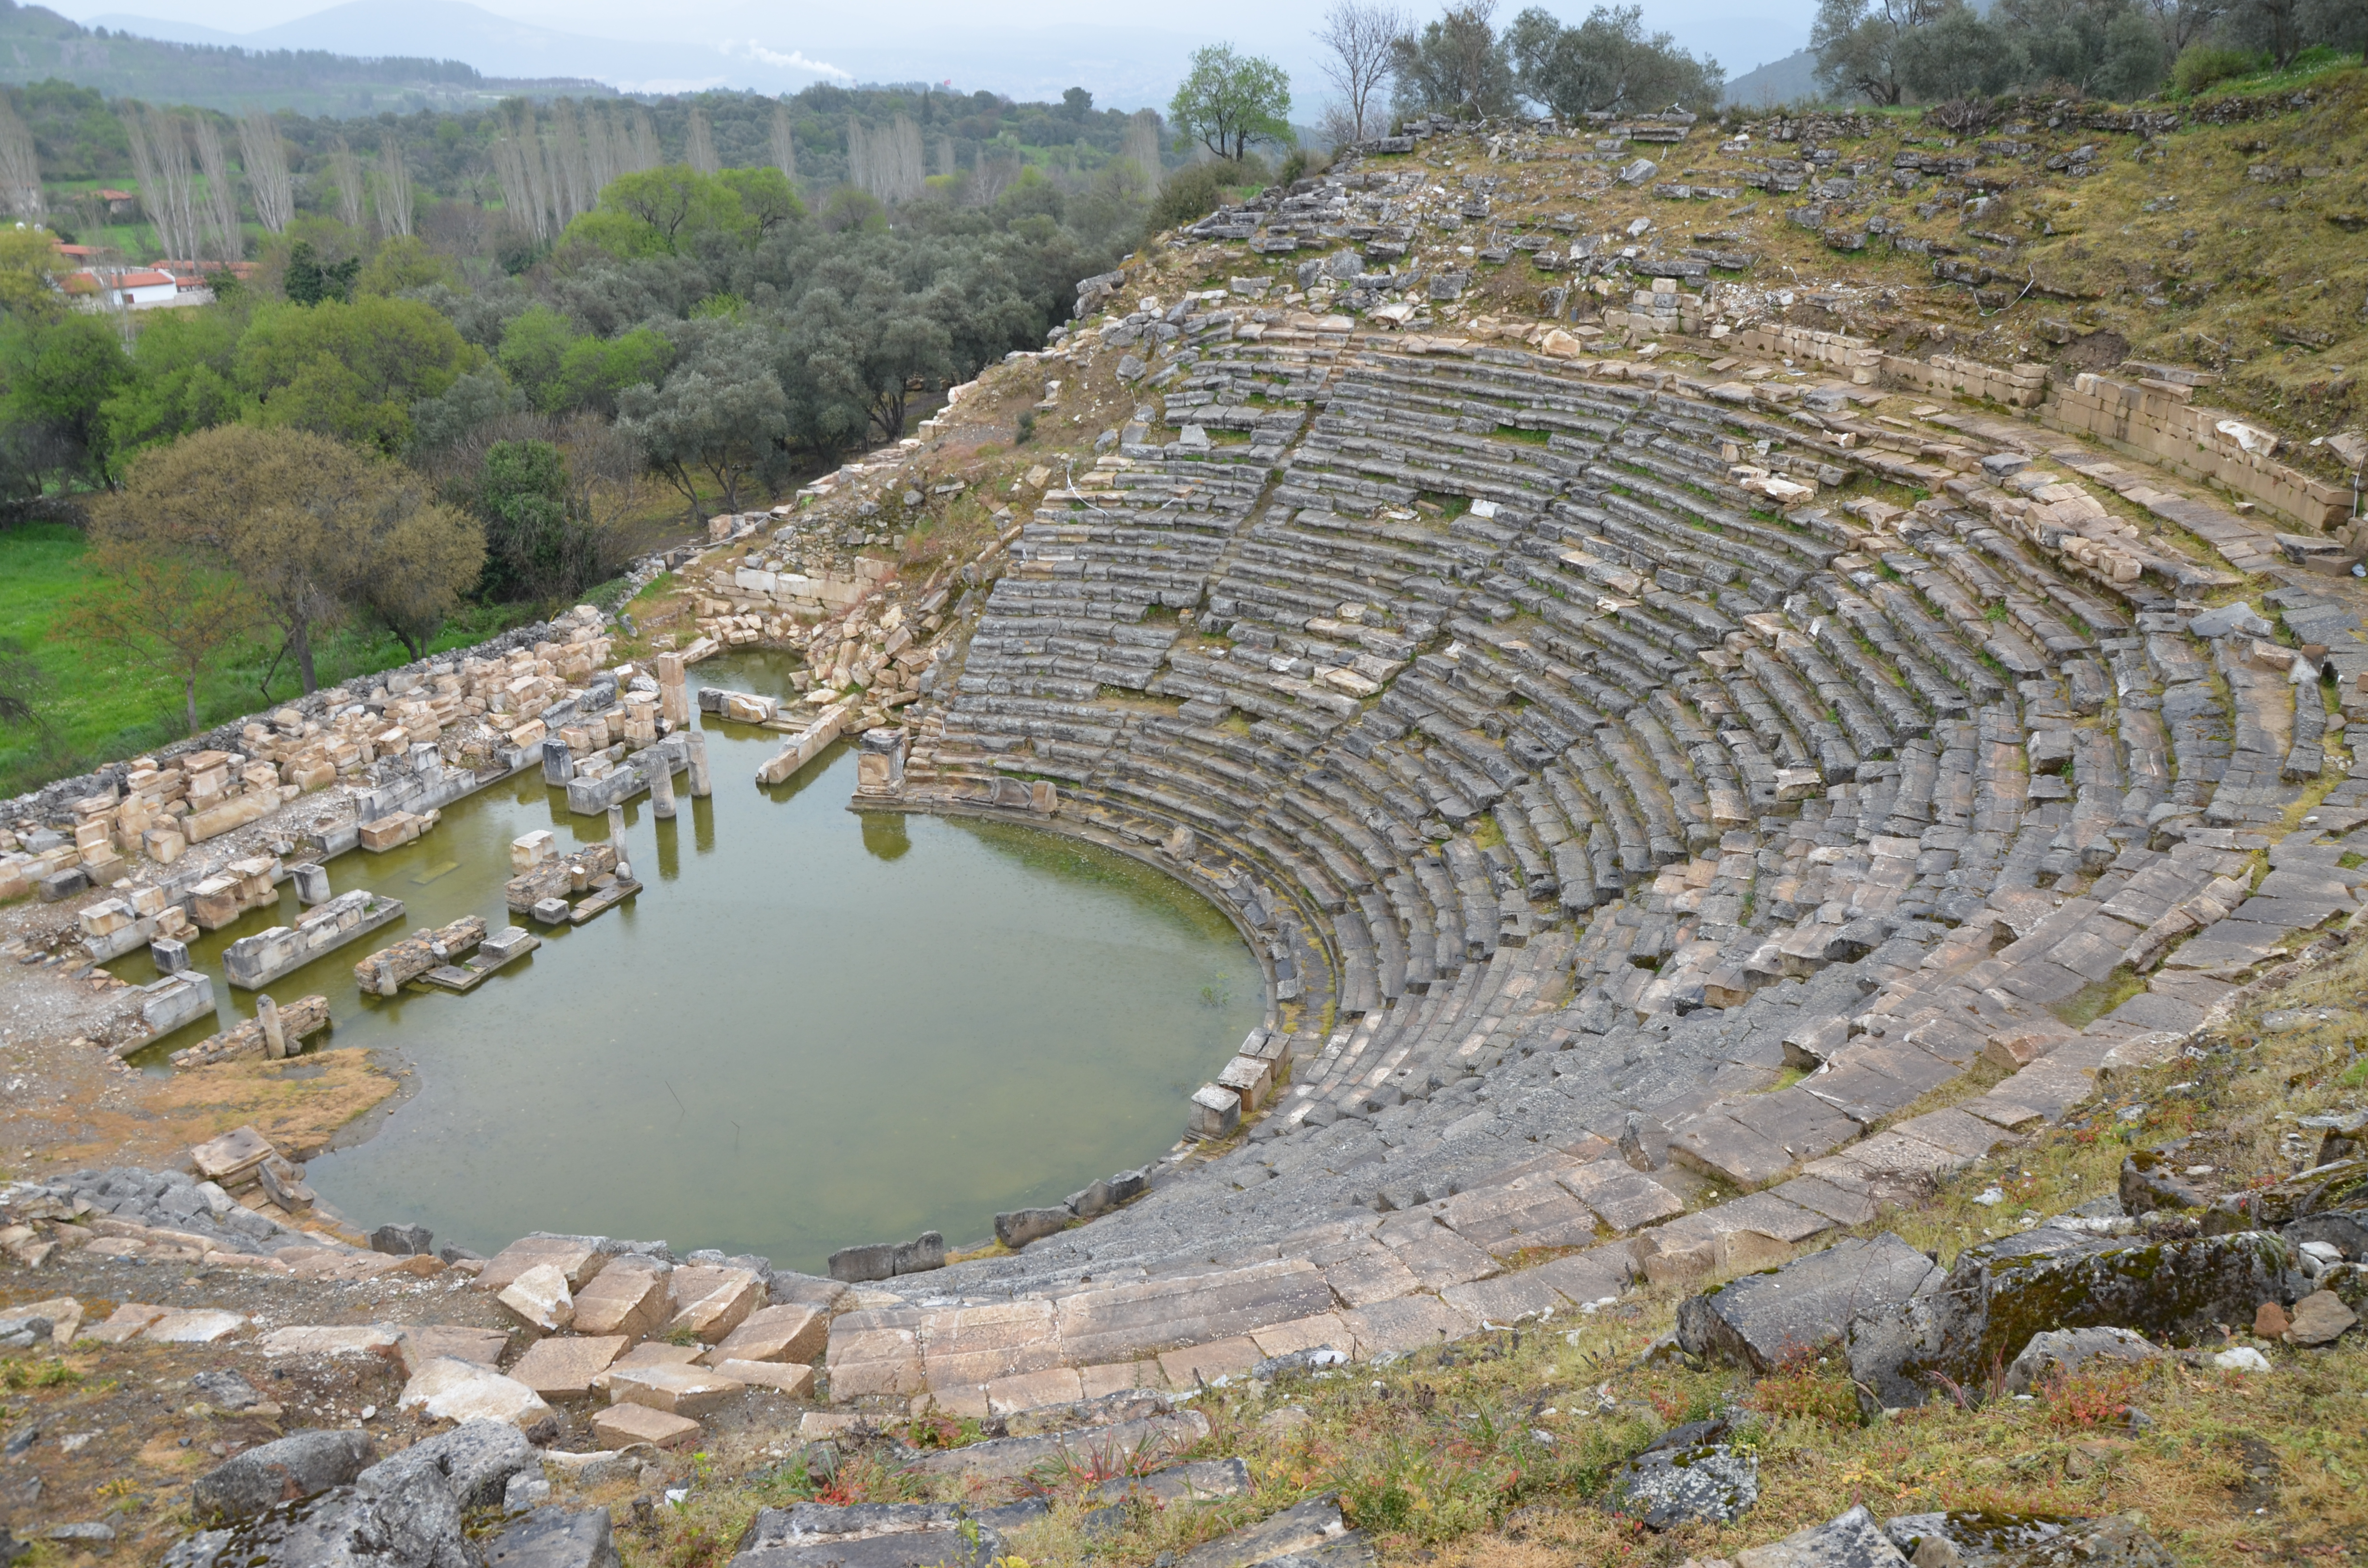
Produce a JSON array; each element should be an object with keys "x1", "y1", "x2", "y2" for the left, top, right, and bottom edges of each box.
[{"x1": 0, "y1": 0, "x2": 606, "y2": 114}]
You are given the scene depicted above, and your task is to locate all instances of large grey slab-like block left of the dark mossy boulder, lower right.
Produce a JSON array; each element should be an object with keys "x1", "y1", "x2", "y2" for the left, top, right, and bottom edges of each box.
[{"x1": 1677, "y1": 1232, "x2": 1942, "y2": 1372}]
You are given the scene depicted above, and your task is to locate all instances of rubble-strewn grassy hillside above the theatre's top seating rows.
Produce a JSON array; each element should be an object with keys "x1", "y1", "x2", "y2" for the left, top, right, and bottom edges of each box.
[{"x1": 1378, "y1": 57, "x2": 2368, "y2": 464}]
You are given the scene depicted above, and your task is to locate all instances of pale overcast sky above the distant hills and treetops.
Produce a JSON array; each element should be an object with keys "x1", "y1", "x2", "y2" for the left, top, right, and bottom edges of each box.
[{"x1": 48, "y1": 0, "x2": 1816, "y2": 106}]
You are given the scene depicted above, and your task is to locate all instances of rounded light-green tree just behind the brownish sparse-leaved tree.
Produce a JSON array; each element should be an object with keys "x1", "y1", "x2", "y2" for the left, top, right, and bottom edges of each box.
[{"x1": 234, "y1": 294, "x2": 483, "y2": 453}]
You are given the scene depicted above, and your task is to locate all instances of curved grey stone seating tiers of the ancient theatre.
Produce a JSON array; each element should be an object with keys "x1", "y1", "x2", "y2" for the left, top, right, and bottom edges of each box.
[{"x1": 904, "y1": 313, "x2": 2356, "y2": 1293}]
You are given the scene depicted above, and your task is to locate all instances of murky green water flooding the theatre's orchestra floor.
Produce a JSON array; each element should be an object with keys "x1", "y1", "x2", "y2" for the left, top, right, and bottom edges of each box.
[{"x1": 114, "y1": 654, "x2": 1262, "y2": 1270}]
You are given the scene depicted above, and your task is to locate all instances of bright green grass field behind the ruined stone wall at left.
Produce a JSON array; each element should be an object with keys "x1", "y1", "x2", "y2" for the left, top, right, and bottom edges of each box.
[{"x1": 0, "y1": 524, "x2": 533, "y2": 796}]
